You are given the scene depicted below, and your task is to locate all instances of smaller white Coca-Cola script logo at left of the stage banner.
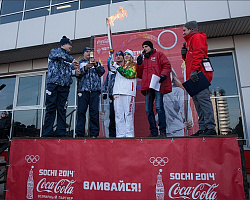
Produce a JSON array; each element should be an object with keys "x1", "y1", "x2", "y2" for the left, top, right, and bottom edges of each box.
[{"x1": 36, "y1": 178, "x2": 76, "y2": 194}]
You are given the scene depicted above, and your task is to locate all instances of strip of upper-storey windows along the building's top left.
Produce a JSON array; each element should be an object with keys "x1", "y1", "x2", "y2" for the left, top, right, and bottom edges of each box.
[{"x1": 0, "y1": 0, "x2": 129, "y2": 24}]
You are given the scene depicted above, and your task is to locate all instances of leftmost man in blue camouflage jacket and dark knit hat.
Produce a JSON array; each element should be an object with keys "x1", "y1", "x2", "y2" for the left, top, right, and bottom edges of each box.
[{"x1": 43, "y1": 36, "x2": 80, "y2": 137}]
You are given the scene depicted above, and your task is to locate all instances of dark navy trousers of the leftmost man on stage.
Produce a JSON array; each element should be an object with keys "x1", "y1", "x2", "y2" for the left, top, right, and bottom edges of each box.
[{"x1": 43, "y1": 83, "x2": 69, "y2": 136}]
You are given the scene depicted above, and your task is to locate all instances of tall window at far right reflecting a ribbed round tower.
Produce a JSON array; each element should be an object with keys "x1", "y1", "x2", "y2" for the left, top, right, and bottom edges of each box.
[{"x1": 209, "y1": 53, "x2": 241, "y2": 134}]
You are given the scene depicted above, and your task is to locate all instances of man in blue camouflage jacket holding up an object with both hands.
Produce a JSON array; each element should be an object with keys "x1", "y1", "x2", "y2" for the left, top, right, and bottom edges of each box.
[{"x1": 76, "y1": 47, "x2": 105, "y2": 138}]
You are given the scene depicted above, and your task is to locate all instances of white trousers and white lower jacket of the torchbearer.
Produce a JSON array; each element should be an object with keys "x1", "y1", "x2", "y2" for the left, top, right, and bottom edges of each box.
[{"x1": 113, "y1": 62, "x2": 137, "y2": 137}]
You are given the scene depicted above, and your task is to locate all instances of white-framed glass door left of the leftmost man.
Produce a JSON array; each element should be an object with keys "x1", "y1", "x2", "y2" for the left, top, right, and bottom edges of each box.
[{"x1": 12, "y1": 73, "x2": 45, "y2": 137}]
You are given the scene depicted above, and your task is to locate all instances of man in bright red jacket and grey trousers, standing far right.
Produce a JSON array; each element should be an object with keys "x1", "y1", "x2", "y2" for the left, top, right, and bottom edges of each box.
[{"x1": 181, "y1": 21, "x2": 216, "y2": 136}]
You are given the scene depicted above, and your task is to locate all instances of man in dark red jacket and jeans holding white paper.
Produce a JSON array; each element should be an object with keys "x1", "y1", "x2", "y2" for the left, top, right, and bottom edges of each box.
[{"x1": 137, "y1": 41, "x2": 172, "y2": 137}]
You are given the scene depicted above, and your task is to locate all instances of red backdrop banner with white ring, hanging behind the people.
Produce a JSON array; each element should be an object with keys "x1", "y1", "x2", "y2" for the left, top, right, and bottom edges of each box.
[{"x1": 94, "y1": 27, "x2": 198, "y2": 137}]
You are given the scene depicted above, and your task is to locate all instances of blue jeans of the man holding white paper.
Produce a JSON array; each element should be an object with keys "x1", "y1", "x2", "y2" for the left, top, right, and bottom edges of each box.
[{"x1": 145, "y1": 89, "x2": 166, "y2": 135}]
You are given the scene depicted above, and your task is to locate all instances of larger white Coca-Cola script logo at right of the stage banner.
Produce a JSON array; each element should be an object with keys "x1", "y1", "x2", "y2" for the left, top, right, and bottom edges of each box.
[{"x1": 168, "y1": 183, "x2": 219, "y2": 200}]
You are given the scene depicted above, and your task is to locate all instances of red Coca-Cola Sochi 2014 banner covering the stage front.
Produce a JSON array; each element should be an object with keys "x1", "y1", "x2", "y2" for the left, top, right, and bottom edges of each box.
[{"x1": 6, "y1": 138, "x2": 245, "y2": 200}]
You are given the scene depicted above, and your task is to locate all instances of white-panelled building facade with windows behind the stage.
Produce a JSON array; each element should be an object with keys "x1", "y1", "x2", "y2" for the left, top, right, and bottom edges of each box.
[{"x1": 0, "y1": 0, "x2": 250, "y2": 147}]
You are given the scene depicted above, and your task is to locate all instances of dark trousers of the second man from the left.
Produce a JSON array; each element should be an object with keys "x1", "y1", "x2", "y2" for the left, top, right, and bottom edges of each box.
[{"x1": 76, "y1": 92, "x2": 100, "y2": 137}]
